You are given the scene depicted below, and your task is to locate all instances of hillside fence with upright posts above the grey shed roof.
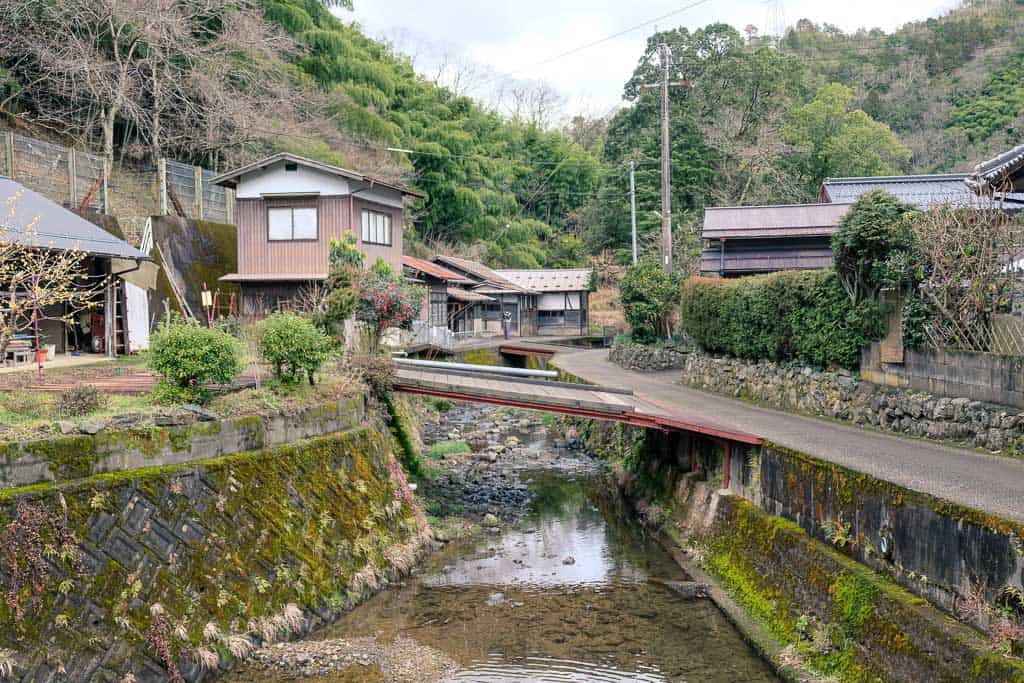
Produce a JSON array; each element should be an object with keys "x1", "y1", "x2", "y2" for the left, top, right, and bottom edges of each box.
[{"x1": 0, "y1": 131, "x2": 234, "y2": 231}]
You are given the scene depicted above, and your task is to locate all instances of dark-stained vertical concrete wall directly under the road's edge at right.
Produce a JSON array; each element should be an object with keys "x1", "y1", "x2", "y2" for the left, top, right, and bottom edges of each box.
[{"x1": 750, "y1": 443, "x2": 1024, "y2": 612}]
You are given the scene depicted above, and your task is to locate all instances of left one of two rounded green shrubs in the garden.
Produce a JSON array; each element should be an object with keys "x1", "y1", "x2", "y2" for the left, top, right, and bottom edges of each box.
[{"x1": 148, "y1": 322, "x2": 241, "y2": 402}]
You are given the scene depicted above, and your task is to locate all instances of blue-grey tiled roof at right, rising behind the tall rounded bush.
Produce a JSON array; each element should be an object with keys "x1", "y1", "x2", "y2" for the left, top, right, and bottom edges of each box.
[{"x1": 821, "y1": 173, "x2": 1024, "y2": 210}]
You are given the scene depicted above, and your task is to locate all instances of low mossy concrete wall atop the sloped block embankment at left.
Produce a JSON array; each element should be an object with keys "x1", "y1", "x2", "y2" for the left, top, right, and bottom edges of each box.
[{"x1": 0, "y1": 396, "x2": 367, "y2": 492}]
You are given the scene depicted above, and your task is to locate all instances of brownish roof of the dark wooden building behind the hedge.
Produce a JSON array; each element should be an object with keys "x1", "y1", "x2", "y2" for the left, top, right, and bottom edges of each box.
[{"x1": 702, "y1": 203, "x2": 850, "y2": 240}]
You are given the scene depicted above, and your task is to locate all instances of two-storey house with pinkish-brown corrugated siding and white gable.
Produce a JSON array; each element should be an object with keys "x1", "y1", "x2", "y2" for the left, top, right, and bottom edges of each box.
[{"x1": 213, "y1": 153, "x2": 423, "y2": 316}]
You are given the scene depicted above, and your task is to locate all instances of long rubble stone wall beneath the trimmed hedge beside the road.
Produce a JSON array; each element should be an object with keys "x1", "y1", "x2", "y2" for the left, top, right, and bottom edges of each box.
[{"x1": 682, "y1": 352, "x2": 1024, "y2": 454}]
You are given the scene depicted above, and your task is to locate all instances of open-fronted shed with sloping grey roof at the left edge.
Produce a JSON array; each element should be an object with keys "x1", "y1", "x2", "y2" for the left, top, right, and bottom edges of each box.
[{"x1": 0, "y1": 176, "x2": 158, "y2": 364}]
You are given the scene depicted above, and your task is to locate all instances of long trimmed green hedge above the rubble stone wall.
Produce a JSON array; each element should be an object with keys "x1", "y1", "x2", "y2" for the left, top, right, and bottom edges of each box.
[{"x1": 682, "y1": 270, "x2": 885, "y2": 369}]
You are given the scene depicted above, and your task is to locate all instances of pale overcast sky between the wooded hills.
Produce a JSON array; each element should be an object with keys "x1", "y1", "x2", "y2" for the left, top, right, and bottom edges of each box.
[{"x1": 348, "y1": 0, "x2": 953, "y2": 115}]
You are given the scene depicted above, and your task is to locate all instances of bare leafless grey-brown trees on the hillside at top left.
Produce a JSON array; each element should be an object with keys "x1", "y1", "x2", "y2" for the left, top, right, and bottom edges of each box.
[{"x1": 0, "y1": 0, "x2": 309, "y2": 160}]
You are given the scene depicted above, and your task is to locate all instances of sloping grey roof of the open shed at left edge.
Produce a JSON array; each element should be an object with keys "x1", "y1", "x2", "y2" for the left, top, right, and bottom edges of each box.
[{"x1": 0, "y1": 176, "x2": 153, "y2": 261}]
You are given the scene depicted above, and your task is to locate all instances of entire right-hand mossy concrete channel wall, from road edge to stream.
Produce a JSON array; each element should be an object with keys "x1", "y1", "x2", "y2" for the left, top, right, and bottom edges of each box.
[{"x1": 578, "y1": 423, "x2": 1024, "y2": 681}]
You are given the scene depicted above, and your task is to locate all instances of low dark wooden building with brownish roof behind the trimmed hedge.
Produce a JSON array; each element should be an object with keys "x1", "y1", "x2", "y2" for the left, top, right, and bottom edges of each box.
[{"x1": 700, "y1": 204, "x2": 850, "y2": 278}]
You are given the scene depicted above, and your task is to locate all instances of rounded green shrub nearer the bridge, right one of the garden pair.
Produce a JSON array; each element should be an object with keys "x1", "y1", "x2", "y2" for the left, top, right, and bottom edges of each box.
[{"x1": 256, "y1": 313, "x2": 334, "y2": 384}]
